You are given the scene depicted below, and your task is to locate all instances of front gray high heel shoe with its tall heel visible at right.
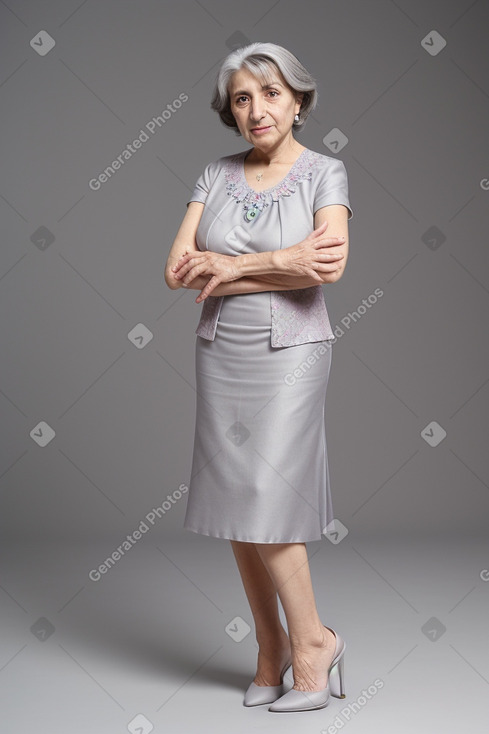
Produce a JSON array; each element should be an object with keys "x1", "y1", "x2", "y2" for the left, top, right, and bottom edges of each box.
[{"x1": 268, "y1": 625, "x2": 346, "y2": 712}]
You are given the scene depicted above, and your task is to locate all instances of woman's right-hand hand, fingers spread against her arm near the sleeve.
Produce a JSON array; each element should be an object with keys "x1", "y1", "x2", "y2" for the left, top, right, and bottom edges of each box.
[{"x1": 272, "y1": 221, "x2": 345, "y2": 283}]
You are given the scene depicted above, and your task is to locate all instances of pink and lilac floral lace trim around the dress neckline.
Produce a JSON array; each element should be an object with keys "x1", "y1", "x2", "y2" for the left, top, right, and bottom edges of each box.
[{"x1": 224, "y1": 148, "x2": 319, "y2": 211}]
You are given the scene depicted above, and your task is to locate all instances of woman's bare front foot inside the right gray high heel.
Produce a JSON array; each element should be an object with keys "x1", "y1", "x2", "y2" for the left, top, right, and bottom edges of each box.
[{"x1": 292, "y1": 626, "x2": 336, "y2": 691}]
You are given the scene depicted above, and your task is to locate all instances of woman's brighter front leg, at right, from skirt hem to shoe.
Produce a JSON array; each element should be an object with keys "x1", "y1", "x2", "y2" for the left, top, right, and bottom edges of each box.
[{"x1": 254, "y1": 543, "x2": 336, "y2": 691}]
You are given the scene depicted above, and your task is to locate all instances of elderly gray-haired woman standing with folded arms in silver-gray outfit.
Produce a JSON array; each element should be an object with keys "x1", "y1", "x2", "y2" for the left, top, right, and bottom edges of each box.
[{"x1": 165, "y1": 43, "x2": 353, "y2": 712}]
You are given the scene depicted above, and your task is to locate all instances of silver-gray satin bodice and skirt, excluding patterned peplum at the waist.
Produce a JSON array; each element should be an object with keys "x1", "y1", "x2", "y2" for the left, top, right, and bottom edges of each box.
[{"x1": 184, "y1": 148, "x2": 353, "y2": 543}]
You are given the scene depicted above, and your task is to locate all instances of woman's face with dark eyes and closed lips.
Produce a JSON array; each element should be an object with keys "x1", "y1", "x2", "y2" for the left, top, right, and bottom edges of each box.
[{"x1": 228, "y1": 66, "x2": 303, "y2": 150}]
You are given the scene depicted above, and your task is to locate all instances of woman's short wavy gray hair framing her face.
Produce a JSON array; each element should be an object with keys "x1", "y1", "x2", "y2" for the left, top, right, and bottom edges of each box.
[{"x1": 211, "y1": 42, "x2": 318, "y2": 135}]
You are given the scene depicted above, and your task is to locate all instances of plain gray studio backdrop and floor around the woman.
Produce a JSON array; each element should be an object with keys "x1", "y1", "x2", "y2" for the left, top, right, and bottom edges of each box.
[{"x1": 0, "y1": 0, "x2": 489, "y2": 734}]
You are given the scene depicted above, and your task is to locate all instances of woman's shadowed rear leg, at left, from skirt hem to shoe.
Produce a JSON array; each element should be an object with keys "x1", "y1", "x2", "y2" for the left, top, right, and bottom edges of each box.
[{"x1": 230, "y1": 540, "x2": 291, "y2": 686}]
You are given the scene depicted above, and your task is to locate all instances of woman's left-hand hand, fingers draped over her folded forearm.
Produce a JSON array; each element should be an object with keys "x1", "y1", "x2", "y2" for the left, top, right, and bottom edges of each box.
[{"x1": 172, "y1": 250, "x2": 242, "y2": 298}]
